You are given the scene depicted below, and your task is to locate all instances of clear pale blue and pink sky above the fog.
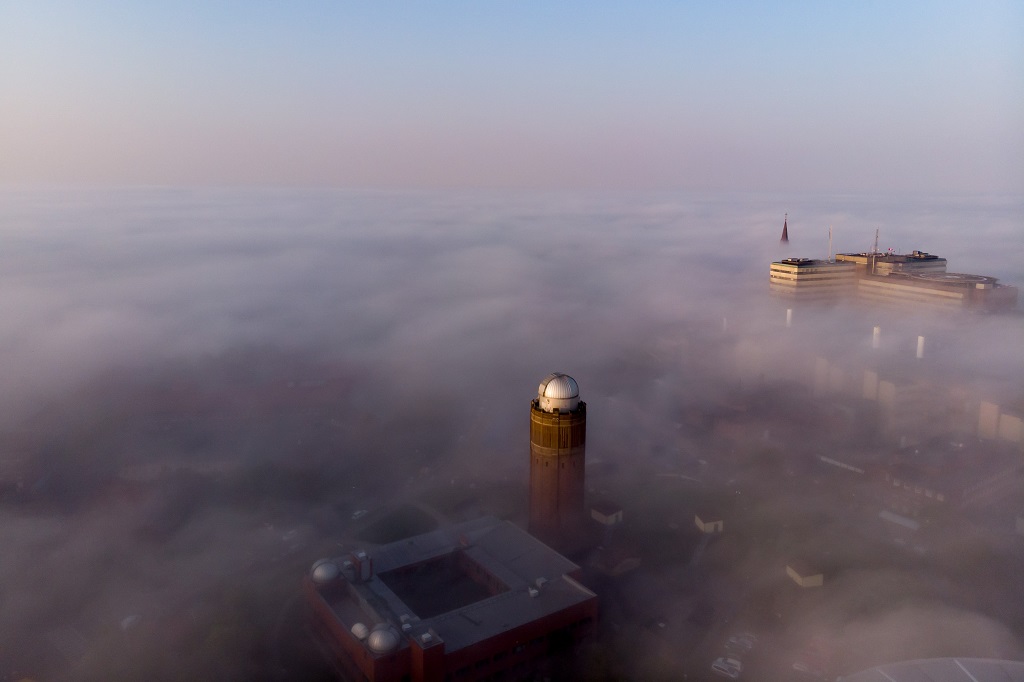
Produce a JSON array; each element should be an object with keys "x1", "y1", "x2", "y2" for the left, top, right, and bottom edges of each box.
[{"x1": 0, "y1": 0, "x2": 1024, "y2": 195}]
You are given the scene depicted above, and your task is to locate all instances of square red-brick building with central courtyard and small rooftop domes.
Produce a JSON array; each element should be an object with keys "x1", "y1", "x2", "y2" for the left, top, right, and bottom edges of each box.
[{"x1": 304, "y1": 516, "x2": 597, "y2": 682}]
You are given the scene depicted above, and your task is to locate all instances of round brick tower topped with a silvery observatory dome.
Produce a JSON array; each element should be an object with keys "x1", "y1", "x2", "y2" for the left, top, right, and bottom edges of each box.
[{"x1": 529, "y1": 372, "x2": 587, "y2": 548}]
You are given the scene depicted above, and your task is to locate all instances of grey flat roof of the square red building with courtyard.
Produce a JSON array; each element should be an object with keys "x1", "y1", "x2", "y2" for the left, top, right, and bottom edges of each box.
[{"x1": 321, "y1": 516, "x2": 596, "y2": 652}]
